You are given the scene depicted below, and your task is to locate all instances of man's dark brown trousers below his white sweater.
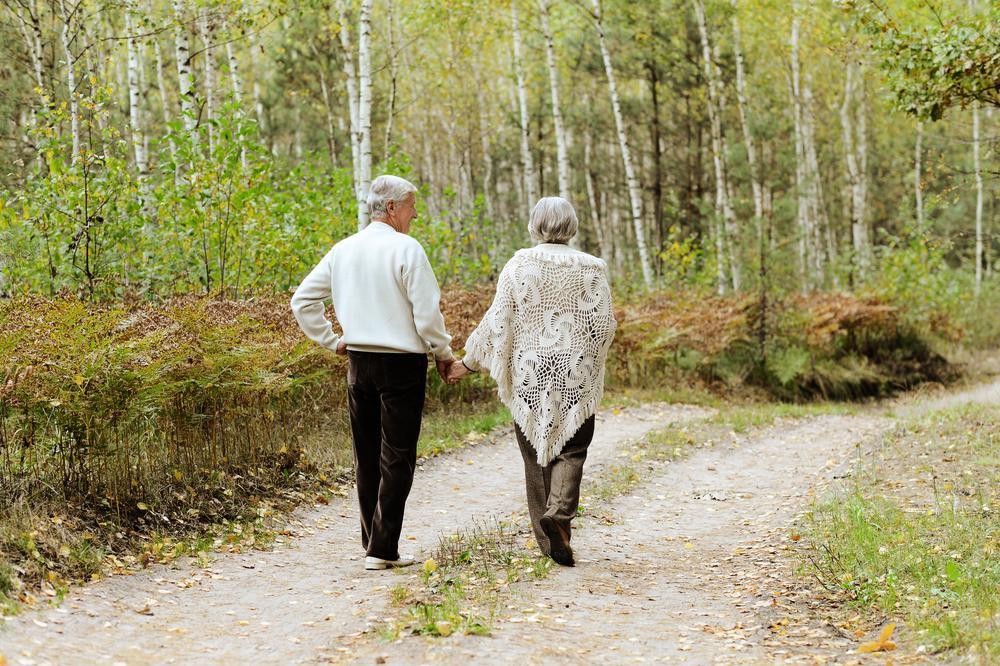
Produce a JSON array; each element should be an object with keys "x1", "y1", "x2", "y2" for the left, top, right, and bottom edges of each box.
[{"x1": 347, "y1": 351, "x2": 427, "y2": 560}]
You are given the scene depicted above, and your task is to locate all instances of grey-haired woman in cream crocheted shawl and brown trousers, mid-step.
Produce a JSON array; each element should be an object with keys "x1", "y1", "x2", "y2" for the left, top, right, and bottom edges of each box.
[{"x1": 449, "y1": 197, "x2": 616, "y2": 566}]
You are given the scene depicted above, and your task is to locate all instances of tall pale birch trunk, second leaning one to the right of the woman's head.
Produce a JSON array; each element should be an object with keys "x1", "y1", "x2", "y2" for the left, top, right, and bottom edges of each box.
[{"x1": 692, "y1": 0, "x2": 740, "y2": 294}]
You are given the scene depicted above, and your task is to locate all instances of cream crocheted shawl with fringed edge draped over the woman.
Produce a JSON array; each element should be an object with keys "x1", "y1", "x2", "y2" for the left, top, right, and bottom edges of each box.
[{"x1": 465, "y1": 244, "x2": 617, "y2": 466}]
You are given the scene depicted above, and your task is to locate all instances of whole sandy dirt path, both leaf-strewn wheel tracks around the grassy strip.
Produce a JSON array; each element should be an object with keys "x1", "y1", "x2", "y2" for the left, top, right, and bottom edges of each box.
[{"x1": 0, "y1": 382, "x2": 1000, "y2": 665}]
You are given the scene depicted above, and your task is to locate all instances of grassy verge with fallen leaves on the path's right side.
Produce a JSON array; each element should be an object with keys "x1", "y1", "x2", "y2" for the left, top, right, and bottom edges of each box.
[{"x1": 805, "y1": 407, "x2": 1000, "y2": 662}]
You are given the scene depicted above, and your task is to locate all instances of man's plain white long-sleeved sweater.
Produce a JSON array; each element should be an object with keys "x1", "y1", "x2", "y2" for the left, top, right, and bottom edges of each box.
[{"x1": 292, "y1": 222, "x2": 454, "y2": 361}]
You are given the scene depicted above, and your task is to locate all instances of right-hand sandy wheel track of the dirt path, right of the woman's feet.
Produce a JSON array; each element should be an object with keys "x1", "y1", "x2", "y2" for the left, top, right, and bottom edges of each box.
[{"x1": 357, "y1": 416, "x2": 891, "y2": 664}]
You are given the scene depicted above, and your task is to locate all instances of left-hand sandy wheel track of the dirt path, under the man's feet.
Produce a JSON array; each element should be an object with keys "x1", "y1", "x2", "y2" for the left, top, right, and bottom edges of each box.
[{"x1": 0, "y1": 405, "x2": 711, "y2": 666}]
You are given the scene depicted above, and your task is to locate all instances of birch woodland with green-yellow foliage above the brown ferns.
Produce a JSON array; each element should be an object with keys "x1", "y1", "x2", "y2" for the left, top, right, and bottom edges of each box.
[{"x1": 0, "y1": 0, "x2": 1000, "y2": 300}]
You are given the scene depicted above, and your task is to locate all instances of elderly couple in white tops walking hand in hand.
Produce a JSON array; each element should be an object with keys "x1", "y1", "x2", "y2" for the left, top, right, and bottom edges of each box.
[{"x1": 291, "y1": 176, "x2": 616, "y2": 569}]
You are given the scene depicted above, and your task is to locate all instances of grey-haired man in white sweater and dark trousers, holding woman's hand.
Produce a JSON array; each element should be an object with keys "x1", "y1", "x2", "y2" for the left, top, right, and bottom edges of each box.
[{"x1": 292, "y1": 176, "x2": 455, "y2": 569}]
